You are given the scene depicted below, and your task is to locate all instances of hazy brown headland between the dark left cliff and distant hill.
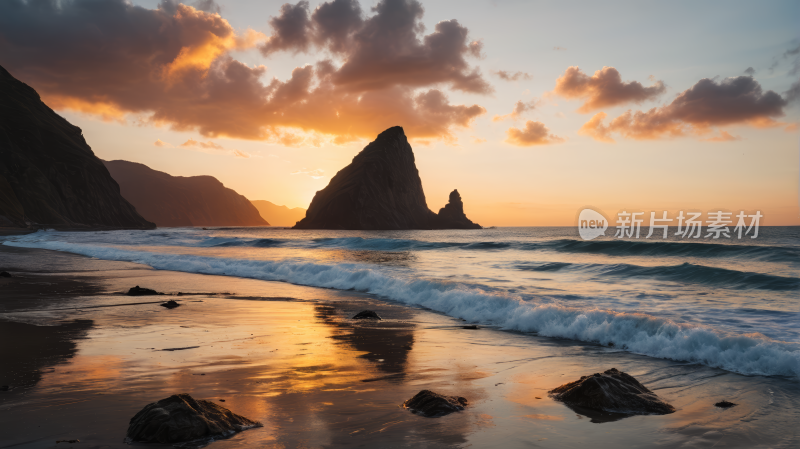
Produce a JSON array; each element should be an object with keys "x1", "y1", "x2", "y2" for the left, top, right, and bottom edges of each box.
[{"x1": 103, "y1": 161, "x2": 269, "y2": 227}]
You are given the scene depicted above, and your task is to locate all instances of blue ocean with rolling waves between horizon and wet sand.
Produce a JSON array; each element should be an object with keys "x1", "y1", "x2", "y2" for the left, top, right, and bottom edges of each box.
[{"x1": 0, "y1": 227, "x2": 800, "y2": 380}]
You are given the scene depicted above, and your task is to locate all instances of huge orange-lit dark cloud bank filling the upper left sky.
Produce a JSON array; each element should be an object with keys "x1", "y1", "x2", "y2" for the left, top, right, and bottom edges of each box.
[{"x1": 0, "y1": 0, "x2": 491, "y2": 142}]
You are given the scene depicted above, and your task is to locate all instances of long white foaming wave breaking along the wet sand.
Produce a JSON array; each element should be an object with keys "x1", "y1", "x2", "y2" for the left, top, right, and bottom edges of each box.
[{"x1": 5, "y1": 239, "x2": 800, "y2": 377}]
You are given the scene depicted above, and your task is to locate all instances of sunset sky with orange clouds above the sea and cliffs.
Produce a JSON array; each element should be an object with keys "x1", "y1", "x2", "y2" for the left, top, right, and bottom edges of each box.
[{"x1": 0, "y1": 0, "x2": 800, "y2": 226}]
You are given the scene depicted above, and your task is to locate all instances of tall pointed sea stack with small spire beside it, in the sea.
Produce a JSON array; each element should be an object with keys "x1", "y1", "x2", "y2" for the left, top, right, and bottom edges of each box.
[{"x1": 294, "y1": 126, "x2": 480, "y2": 230}]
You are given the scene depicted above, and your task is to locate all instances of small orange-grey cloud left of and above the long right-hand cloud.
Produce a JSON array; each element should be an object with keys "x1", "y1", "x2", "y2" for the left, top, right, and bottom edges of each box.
[{"x1": 553, "y1": 66, "x2": 667, "y2": 113}]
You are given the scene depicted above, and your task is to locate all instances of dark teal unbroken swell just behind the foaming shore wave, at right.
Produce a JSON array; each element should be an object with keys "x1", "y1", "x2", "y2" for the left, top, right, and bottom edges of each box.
[{"x1": 516, "y1": 262, "x2": 800, "y2": 291}]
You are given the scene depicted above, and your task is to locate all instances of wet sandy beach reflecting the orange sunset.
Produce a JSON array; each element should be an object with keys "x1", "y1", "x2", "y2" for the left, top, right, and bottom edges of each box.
[{"x1": 0, "y1": 245, "x2": 800, "y2": 448}]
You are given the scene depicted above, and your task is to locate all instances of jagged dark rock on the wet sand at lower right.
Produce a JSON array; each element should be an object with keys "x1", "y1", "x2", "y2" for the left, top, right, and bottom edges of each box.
[{"x1": 550, "y1": 368, "x2": 675, "y2": 415}]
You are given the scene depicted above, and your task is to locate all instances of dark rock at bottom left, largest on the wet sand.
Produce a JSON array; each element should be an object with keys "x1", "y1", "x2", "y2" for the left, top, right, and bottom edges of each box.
[{"x1": 126, "y1": 394, "x2": 262, "y2": 444}]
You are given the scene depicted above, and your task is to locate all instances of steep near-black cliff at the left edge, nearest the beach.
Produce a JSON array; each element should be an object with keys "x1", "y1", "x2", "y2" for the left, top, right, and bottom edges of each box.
[{"x1": 0, "y1": 67, "x2": 154, "y2": 229}]
